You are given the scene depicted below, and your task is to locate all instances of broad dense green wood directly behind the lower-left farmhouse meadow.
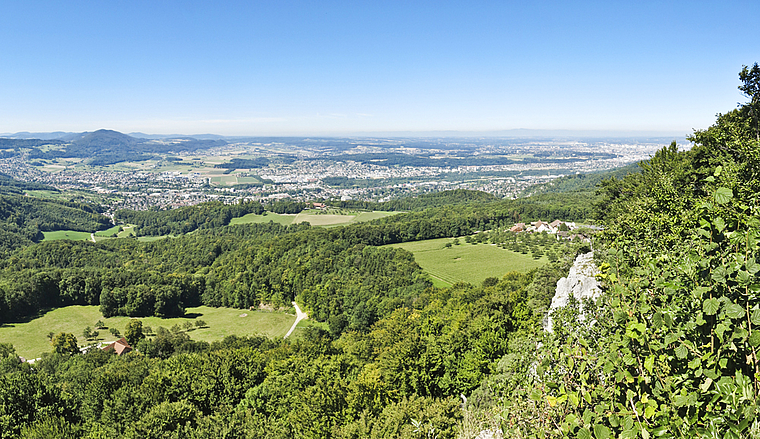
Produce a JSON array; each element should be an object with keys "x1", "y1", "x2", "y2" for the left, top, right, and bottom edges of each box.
[{"x1": 0, "y1": 223, "x2": 430, "y2": 329}]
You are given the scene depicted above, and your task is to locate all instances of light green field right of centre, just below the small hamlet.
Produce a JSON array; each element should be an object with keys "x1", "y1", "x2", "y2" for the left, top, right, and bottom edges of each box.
[{"x1": 391, "y1": 238, "x2": 549, "y2": 287}]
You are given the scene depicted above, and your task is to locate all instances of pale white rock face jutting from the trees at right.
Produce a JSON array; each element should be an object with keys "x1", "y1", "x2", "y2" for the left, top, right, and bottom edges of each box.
[{"x1": 544, "y1": 252, "x2": 601, "y2": 332}]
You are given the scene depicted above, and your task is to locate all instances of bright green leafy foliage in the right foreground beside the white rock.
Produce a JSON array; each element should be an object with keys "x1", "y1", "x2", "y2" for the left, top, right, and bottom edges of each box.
[{"x1": 470, "y1": 65, "x2": 760, "y2": 439}]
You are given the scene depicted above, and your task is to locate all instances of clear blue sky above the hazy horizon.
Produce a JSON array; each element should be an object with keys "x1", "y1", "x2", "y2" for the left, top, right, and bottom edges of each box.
[{"x1": 0, "y1": 0, "x2": 760, "y2": 135}]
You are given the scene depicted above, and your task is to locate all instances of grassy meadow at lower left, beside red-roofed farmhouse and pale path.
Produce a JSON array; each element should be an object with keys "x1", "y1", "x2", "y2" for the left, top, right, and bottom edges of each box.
[{"x1": 0, "y1": 306, "x2": 312, "y2": 358}]
